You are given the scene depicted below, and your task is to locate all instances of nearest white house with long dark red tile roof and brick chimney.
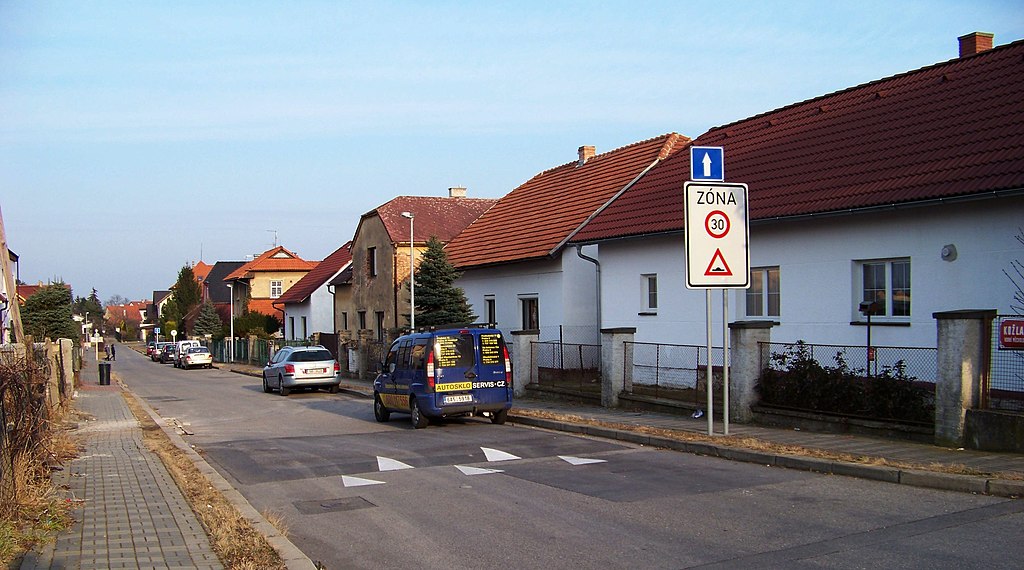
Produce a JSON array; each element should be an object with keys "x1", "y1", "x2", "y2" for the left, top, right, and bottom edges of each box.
[{"x1": 570, "y1": 34, "x2": 1024, "y2": 347}]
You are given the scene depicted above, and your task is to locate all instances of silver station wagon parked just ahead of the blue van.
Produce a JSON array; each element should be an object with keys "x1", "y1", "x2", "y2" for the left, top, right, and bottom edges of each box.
[{"x1": 263, "y1": 346, "x2": 341, "y2": 396}]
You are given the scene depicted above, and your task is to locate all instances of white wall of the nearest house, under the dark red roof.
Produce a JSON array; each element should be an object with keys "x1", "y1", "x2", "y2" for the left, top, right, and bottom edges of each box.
[{"x1": 600, "y1": 196, "x2": 1024, "y2": 347}]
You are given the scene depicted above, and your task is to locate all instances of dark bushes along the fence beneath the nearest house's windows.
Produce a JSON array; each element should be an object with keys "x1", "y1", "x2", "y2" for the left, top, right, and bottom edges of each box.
[{"x1": 757, "y1": 342, "x2": 935, "y2": 424}]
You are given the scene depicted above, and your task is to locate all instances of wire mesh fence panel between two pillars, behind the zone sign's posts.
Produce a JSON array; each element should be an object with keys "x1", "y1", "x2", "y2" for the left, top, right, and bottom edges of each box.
[{"x1": 625, "y1": 342, "x2": 724, "y2": 406}]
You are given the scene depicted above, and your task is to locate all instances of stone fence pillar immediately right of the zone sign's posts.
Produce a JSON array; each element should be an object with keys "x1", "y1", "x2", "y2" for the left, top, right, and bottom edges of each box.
[{"x1": 729, "y1": 320, "x2": 774, "y2": 424}]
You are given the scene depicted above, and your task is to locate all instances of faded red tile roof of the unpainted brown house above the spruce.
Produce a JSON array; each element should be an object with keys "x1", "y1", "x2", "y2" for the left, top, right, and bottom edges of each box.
[{"x1": 362, "y1": 195, "x2": 498, "y2": 244}]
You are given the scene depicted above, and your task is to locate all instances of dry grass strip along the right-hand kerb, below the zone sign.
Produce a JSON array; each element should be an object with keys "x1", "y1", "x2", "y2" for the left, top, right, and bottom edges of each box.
[{"x1": 513, "y1": 409, "x2": 1024, "y2": 481}]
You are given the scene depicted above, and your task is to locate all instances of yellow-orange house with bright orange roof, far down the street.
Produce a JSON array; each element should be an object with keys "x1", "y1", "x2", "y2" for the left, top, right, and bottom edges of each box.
[{"x1": 223, "y1": 246, "x2": 316, "y2": 321}]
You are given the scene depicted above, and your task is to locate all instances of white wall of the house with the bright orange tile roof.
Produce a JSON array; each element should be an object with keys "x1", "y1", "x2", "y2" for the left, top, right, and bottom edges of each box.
[{"x1": 455, "y1": 247, "x2": 598, "y2": 343}]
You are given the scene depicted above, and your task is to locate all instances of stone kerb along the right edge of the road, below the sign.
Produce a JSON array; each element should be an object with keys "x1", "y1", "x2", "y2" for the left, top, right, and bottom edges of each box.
[{"x1": 509, "y1": 413, "x2": 1024, "y2": 498}]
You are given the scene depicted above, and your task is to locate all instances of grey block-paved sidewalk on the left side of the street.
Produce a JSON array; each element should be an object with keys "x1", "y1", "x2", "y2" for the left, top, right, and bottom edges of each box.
[{"x1": 20, "y1": 358, "x2": 222, "y2": 570}]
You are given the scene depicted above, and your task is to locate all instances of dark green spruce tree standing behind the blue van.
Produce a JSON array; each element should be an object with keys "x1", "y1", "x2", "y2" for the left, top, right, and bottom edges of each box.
[{"x1": 416, "y1": 236, "x2": 476, "y2": 326}]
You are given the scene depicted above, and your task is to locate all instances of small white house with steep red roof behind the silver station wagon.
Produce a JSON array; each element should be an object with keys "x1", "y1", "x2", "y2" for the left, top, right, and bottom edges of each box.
[{"x1": 273, "y1": 242, "x2": 352, "y2": 341}]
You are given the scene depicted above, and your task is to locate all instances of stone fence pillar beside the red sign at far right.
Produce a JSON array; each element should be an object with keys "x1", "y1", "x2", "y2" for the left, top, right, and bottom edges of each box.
[{"x1": 932, "y1": 309, "x2": 996, "y2": 447}]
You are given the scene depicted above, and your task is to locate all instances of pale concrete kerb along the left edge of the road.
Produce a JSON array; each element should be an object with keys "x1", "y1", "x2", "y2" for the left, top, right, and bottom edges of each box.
[{"x1": 119, "y1": 383, "x2": 316, "y2": 570}]
